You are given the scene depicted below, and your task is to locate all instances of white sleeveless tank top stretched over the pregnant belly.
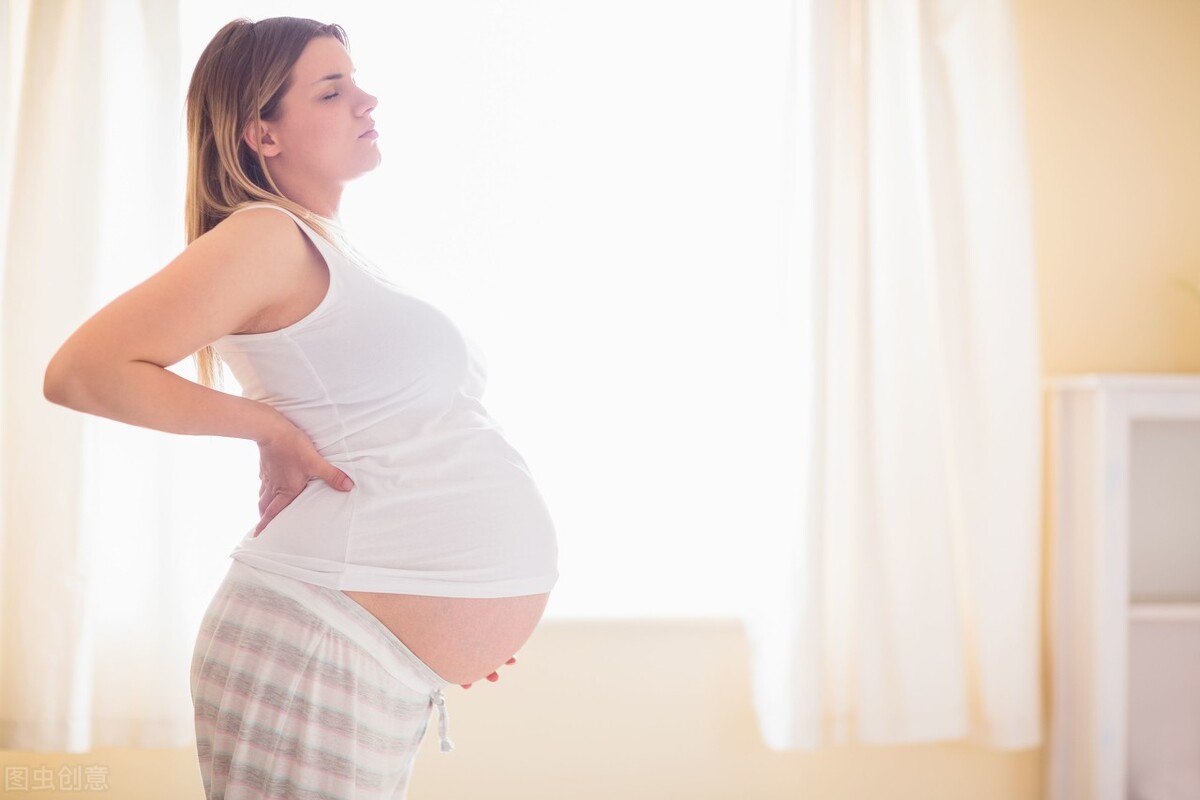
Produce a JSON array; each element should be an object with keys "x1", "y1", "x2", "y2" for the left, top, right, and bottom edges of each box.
[{"x1": 212, "y1": 203, "x2": 558, "y2": 597}]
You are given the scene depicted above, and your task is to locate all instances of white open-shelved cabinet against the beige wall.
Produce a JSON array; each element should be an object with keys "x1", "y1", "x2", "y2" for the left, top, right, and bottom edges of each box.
[{"x1": 1045, "y1": 375, "x2": 1200, "y2": 800}]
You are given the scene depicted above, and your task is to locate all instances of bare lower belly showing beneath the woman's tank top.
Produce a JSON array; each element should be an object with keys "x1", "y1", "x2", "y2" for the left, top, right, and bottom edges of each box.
[{"x1": 342, "y1": 589, "x2": 550, "y2": 684}]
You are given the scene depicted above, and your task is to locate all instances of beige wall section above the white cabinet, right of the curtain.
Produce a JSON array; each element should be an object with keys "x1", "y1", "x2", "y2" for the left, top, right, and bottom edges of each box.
[{"x1": 1016, "y1": 0, "x2": 1200, "y2": 374}]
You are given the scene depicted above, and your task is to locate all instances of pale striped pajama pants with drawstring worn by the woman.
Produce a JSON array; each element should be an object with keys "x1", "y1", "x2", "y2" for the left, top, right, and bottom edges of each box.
[{"x1": 191, "y1": 560, "x2": 452, "y2": 800}]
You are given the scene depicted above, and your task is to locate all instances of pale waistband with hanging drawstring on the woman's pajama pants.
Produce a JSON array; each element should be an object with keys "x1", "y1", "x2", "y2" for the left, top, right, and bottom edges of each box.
[{"x1": 226, "y1": 559, "x2": 454, "y2": 752}]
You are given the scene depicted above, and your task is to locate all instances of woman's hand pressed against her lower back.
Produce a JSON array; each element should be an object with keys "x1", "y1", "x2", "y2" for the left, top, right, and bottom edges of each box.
[{"x1": 253, "y1": 426, "x2": 353, "y2": 536}]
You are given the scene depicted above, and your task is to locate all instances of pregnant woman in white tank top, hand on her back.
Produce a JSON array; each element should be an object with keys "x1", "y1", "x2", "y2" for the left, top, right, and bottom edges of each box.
[{"x1": 44, "y1": 17, "x2": 558, "y2": 800}]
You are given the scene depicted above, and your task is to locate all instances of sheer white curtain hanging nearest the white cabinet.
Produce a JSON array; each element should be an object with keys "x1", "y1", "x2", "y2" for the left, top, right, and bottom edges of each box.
[{"x1": 749, "y1": 0, "x2": 1042, "y2": 748}]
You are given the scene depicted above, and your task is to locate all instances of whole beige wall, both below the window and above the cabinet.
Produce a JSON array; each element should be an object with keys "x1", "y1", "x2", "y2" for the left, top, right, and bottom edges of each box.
[{"x1": 0, "y1": 0, "x2": 1200, "y2": 800}]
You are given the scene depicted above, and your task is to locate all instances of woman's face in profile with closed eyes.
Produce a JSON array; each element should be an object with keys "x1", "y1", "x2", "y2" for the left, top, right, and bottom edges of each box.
[{"x1": 264, "y1": 36, "x2": 380, "y2": 184}]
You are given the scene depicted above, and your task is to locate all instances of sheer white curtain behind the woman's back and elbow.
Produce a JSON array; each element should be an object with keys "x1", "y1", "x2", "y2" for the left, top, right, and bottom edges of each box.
[{"x1": 0, "y1": 0, "x2": 243, "y2": 752}]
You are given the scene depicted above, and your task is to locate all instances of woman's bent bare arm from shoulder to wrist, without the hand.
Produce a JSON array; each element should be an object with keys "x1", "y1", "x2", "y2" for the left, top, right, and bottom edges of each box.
[{"x1": 43, "y1": 209, "x2": 311, "y2": 444}]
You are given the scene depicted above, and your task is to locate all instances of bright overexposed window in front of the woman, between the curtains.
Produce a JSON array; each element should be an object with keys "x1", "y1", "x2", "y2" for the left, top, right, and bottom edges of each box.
[{"x1": 181, "y1": 0, "x2": 787, "y2": 616}]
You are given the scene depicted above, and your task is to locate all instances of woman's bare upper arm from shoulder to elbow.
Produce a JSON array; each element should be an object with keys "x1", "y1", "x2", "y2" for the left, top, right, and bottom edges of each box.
[{"x1": 45, "y1": 206, "x2": 316, "y2": 381}]
